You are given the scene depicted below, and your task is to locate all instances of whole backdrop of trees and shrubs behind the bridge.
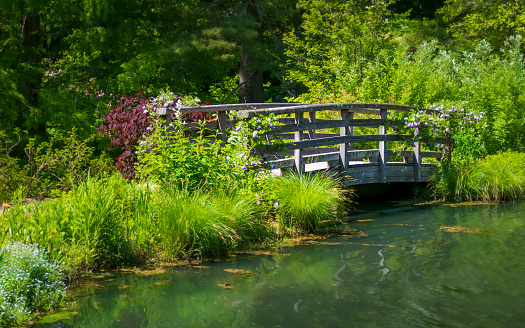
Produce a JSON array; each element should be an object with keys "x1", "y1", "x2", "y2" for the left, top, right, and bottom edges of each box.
[{"x1": 0, "y1": 0, "x2": 525, "y2": 200}]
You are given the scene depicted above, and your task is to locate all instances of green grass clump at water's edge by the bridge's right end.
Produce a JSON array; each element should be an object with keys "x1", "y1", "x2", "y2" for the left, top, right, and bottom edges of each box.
[{"x1": 431, "y1": 152, "x2": 525, "y2": 202}]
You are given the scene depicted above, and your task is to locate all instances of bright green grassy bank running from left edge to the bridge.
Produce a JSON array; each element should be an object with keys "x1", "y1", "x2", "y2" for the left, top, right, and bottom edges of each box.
[{"x1": 0, "y1": 175, "x2": 347, "y2": 326}]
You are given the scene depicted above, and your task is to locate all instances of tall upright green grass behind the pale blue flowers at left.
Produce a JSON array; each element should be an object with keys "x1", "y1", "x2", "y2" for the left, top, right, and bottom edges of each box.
[{"x1": 0, "y1": 176, "x2": 135, "y2": 271}]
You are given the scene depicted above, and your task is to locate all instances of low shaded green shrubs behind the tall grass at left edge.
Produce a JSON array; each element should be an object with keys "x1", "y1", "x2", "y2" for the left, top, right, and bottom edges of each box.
[{"x1": 0, "y1": 129, "x2": 112, "y2": 201}]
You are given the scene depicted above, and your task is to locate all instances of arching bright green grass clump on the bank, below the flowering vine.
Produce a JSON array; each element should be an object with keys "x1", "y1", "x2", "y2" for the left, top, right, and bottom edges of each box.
[{"x1": 154, "y1": 186, "x2": 263, "y2": 258}]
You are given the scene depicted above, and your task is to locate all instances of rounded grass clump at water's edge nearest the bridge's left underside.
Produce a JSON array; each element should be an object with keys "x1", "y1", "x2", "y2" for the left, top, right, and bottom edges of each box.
[{"x1": 269, "y1": 173, "x2": 344, "y2": 232}]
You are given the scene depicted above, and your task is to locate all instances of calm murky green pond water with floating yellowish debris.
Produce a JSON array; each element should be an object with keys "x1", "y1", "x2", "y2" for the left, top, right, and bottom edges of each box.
[{"x1": 33, "y1": 203, "x2": 525, "y2": 327}]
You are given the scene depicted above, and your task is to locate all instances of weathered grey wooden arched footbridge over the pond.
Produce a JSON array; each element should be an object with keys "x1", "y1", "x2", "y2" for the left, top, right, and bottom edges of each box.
[{"x1": 157, "y1": 103, "x2": 454, "y2": 186}]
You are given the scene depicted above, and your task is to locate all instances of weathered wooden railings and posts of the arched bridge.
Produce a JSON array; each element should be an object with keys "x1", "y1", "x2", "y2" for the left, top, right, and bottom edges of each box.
[{"x1": 157, "y1": 103, "x2": 454, "y2": 183}]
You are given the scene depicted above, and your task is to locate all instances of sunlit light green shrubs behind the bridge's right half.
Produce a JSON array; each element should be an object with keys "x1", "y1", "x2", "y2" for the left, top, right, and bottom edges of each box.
[{"x1": 290, "y1": 37, "x2": 525, "y2": 155}]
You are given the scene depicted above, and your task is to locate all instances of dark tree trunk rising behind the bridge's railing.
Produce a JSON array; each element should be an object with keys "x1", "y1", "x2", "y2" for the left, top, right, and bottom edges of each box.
[{"x1": 239, "y1": 0, "x2": 264, "y2": 103}]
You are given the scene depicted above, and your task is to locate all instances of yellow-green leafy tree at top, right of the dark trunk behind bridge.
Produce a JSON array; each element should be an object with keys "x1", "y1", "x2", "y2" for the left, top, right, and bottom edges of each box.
[{"x1": 284, "y1": 0, "x2": 400, "y2": 101}]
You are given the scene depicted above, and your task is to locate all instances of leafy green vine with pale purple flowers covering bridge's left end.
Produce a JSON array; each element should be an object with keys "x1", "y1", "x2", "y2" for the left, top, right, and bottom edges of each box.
[{"x1": 136, "y1": 106, "x2": 277, "y2": 190}]
